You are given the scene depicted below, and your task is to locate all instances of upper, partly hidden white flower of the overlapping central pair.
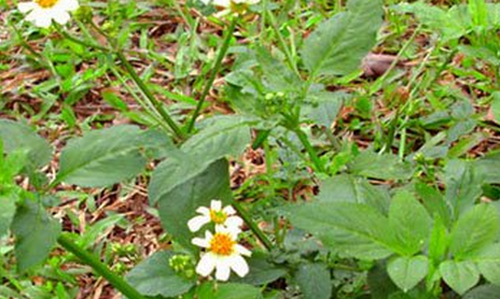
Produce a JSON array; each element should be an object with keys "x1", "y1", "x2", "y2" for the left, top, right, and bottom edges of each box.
[{"x1": 188, "y1": 200, "x2": 243, "y2": 232}]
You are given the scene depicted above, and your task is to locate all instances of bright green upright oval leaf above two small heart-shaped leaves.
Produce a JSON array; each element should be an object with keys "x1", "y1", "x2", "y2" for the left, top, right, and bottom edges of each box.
[{"x1": 389, "y1": 191, "x2": 431, "y2": 256}]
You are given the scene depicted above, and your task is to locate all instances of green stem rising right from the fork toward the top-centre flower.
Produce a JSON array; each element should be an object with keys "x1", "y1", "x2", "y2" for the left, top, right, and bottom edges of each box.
[{"x1": 187, "y1": 17, "x2": 238, "y2": 133}]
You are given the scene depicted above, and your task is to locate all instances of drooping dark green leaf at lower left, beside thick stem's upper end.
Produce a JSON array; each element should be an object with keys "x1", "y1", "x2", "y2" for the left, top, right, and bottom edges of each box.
[{"x1": 11, "y1": 200, "x2": 61, "y2": 272}]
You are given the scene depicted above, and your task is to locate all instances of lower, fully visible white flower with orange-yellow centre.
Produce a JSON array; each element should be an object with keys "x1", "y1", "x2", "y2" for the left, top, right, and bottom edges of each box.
[{"x1": 192, "y1": 226, "x2": 252, "y2": 281}]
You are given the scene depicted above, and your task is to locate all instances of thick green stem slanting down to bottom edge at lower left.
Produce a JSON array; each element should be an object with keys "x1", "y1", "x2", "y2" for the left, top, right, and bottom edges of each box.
[{"x1": 57, "y1": 233, "x2": 146, "y2": 299}]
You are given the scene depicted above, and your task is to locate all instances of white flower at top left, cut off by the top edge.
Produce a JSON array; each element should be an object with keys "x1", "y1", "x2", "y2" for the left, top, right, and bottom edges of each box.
[{"x1": 17, "y1": 0, "x2": 79, "y2": 28}]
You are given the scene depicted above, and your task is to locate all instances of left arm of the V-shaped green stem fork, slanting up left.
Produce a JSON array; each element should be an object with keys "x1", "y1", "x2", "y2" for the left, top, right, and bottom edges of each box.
[{"x1": 116, "y1": 50, "x2": 184, "y2": 140}]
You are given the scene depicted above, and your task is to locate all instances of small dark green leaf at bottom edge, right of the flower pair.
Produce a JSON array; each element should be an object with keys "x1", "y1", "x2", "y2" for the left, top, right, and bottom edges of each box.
[{"x1": 295, "y1": 263, "x2": 332, "y2": 299}]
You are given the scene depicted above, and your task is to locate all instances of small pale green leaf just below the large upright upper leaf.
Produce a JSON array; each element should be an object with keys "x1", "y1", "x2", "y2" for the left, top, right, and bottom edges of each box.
[{"x1": 301, "y1": 91, "x2": 349, "y2": 128}]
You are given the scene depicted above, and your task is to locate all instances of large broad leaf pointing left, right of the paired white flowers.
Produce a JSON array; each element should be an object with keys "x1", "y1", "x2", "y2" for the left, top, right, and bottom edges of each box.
[{"x1": 288, "y1": 203, "x2": 399, "y2": 259}]
